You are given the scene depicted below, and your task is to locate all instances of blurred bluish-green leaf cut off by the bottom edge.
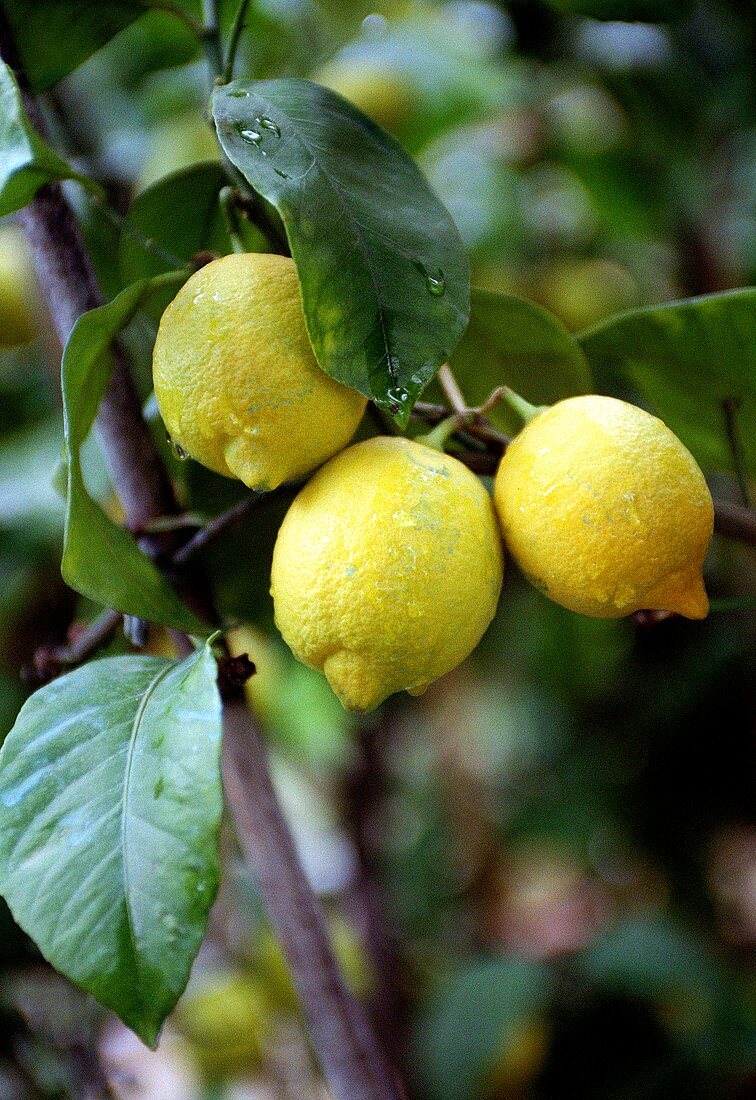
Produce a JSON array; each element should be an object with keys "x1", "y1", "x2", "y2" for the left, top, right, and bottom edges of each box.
[{"x1": 416, "y1": 958, "x2": 552, "y2": 1100}]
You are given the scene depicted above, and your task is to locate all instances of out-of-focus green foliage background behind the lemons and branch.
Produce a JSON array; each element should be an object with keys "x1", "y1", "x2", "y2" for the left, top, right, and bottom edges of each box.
[{"x1": 0, "y1": 0, "x2": 756, "y2": 1100}]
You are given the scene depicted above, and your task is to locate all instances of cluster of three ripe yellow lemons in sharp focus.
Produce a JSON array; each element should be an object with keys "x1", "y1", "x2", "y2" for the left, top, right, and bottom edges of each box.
[{"x1": 154, "y1": 254, "x2": 713, "y2": 711}]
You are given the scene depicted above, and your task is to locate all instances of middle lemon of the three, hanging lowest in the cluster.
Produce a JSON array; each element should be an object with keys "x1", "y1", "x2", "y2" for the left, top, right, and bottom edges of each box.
[{"x1": 271, "y1": 437, "x2": 503, "y2": 711}]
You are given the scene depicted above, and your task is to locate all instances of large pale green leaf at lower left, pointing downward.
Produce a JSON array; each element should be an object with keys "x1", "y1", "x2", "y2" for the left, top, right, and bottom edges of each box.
[{"x1": 0, "y1": 646, "x2": 222, "y2": 1046}]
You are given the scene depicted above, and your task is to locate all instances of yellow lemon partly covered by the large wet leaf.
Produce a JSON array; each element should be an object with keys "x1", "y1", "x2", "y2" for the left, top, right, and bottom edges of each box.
[{"x1": 153, "y1": 252, "x2": 366, "y2": 490}]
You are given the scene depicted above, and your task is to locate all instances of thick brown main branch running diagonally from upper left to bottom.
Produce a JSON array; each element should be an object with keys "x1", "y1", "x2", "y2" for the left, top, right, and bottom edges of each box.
[{"x1": 0, "y1": 19, "x2": 399, "y2": 1100}]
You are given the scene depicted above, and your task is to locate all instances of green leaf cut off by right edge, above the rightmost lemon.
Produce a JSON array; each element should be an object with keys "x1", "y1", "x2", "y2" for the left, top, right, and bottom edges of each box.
[{"x1": 578, "y1": 287, "x2": 756, "y2": 472}]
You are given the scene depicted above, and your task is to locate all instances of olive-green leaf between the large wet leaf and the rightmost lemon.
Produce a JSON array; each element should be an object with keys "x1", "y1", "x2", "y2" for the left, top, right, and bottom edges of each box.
[{"x1": 450, "y1": 287, "x2": 592, "y2": 432}]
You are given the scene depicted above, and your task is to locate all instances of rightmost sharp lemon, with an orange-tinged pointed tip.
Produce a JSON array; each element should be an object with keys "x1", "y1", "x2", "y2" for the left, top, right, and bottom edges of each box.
[{"x1": 494, "y1": 396, "x2": 714, "y2": 619}]
